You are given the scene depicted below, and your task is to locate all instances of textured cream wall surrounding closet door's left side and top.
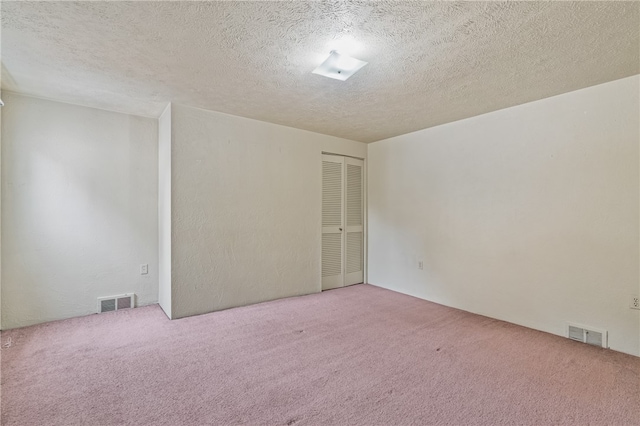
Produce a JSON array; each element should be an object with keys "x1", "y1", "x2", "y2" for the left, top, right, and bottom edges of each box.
[{"x1": 171, "y1": 104, "x2": 366, "y2": 318}]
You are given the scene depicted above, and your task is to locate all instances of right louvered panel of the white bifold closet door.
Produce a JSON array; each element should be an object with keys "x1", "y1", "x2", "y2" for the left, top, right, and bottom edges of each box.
[{"x1": 344, "y1": 157, "x2": 364, "y2": 285}]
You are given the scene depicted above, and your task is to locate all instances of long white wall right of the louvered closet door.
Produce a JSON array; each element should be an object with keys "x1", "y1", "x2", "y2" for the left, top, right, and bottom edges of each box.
[{"x1": 368, "y1": 76, "x2": 640, "y2": 355}]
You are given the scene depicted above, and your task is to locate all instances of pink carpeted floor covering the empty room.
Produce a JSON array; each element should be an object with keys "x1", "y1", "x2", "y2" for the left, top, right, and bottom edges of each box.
[{"x1": 1, "y1": 285, "x2": 640, "y2": 426}]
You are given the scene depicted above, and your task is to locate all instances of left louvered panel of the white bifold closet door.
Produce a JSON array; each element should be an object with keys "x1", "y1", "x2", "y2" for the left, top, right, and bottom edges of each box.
[{"x1": 322, "y1": 155, "x2": 344, "y2": 290}]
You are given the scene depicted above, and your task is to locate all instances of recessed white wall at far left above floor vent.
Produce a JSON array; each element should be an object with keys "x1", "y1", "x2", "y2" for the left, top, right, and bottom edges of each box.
[{"x1": 1, "y1": 93, "x2": 158, "y2": 329}]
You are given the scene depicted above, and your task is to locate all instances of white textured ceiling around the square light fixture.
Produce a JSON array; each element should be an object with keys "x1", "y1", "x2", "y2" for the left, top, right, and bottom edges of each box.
[{"x1": 1, "y1": 0, "x2": 640, "y2": 142}]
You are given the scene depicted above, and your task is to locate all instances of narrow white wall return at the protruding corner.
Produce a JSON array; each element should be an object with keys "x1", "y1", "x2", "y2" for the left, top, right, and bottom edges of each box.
[{"x1": 158, "y1": 104, "x2": 172, "y2": 318}]
